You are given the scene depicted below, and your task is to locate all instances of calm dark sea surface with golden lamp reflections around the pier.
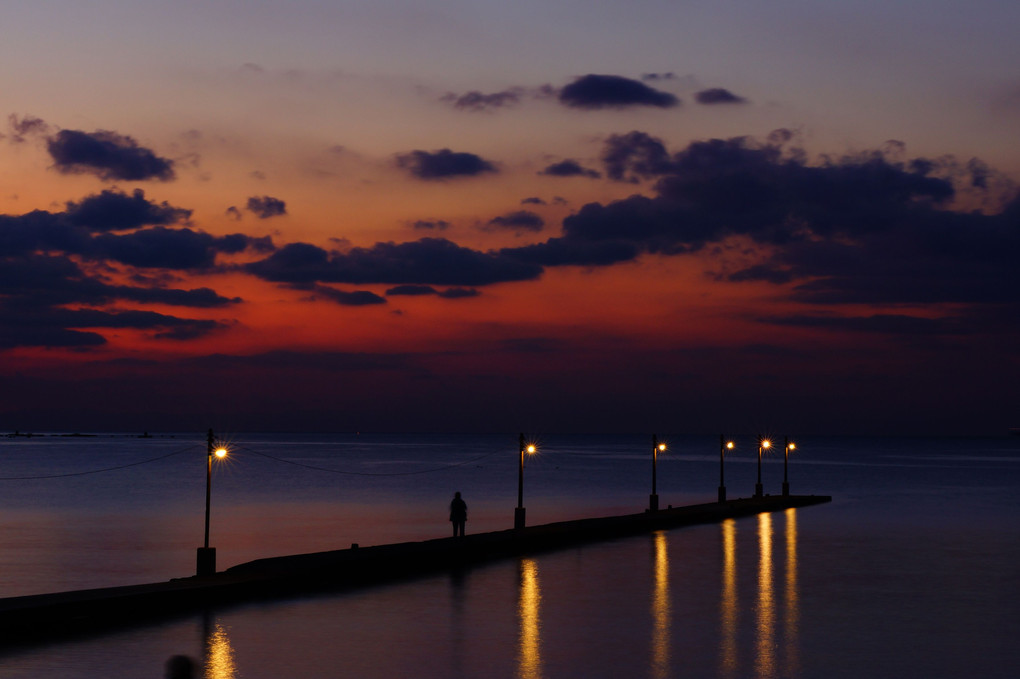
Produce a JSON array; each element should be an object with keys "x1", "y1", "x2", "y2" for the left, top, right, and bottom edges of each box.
[{"x1": 0, "y1": 432, "x2": 1020, "y2": 679}]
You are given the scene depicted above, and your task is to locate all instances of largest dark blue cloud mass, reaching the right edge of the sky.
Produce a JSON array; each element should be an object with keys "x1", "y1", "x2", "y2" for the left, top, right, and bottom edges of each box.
[{"x1": 500, "y1": 132, "x2": 1020, "y2": 340}]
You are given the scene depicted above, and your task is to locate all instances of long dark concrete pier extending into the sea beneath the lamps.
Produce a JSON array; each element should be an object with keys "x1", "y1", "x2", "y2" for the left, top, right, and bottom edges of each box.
[{"x1": 0, "y1": 495, "x2": 831, "y2": 647}]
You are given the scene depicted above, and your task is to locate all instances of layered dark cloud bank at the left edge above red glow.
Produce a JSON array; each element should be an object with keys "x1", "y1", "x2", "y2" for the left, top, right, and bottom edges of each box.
[{"x1": 0, "y1": 190, "x2": 272, "y2": 349}]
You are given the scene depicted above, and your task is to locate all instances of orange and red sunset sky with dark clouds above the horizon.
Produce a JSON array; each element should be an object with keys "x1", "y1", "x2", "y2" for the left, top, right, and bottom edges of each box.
[{"x1": 0, "y1": 0, "x2": 1020, "y2": 434}]
